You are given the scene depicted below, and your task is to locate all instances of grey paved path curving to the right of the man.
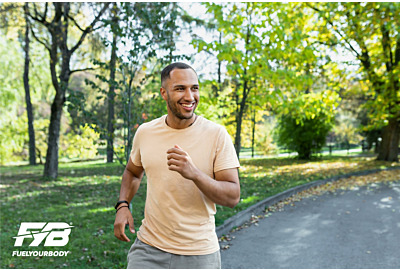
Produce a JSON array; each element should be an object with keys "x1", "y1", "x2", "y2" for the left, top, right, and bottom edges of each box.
[{"x1": 221, "y1": 181, "x2": 400, "y2": 269}]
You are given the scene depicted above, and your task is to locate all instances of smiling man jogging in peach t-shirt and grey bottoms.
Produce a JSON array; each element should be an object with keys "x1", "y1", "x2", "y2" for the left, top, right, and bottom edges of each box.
[{"x1": 114, "y1": 63, "x2": 240, "y2": 268}]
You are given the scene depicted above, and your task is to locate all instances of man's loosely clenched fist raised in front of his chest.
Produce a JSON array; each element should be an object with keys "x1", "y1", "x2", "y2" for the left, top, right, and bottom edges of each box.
[{"x1": 167, "y1": 145, "x2": 199, "y2": 180}]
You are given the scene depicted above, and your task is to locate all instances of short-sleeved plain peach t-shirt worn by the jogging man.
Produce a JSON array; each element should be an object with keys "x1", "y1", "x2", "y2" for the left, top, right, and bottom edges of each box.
[{"x1": 131, "y1": 115, "x2": 240, "y2": 255}]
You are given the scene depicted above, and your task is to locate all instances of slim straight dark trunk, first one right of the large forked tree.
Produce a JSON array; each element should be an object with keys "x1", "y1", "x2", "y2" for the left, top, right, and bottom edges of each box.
[{"x1": 107, "y1": 15, "x2": 117, "y2": 163}]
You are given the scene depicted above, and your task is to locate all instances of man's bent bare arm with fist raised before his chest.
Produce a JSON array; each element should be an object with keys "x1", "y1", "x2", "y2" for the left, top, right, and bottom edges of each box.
[{"x1": 167, "y1": 145, "x2": 240, "y2": 208}]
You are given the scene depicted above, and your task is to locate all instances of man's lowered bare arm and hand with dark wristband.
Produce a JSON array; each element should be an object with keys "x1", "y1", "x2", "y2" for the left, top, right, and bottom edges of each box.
[{"x1": 114, "y1": 158, "x2": 144, "y2": 242}]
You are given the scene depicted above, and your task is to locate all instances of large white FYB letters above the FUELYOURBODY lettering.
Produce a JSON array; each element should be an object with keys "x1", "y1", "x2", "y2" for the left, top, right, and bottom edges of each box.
[{"x1": 13, "y1": 222, "x2": 74, "y2": 247}]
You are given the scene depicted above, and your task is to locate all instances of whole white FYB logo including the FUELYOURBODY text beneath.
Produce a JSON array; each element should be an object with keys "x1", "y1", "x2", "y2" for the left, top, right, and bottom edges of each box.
[{"x1": 13, "y1": 222, "x2": 74, "y2": 256}]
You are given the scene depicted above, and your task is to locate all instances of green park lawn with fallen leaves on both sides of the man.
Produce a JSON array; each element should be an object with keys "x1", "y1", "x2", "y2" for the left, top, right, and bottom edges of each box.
[{"x1": 0, "y1": 157, "x2": 398, "y2": 268}]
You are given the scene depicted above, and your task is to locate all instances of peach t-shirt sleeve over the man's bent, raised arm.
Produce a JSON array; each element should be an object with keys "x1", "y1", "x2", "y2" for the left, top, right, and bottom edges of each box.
[{"x1": 214, "y1": 127, "x2": 240, "y2": 172}]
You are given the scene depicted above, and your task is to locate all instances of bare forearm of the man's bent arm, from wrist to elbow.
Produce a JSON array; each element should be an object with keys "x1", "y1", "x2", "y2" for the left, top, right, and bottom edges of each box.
[{"x1": 192, "y1": 170, "x2": 240, "y2": 208}]
